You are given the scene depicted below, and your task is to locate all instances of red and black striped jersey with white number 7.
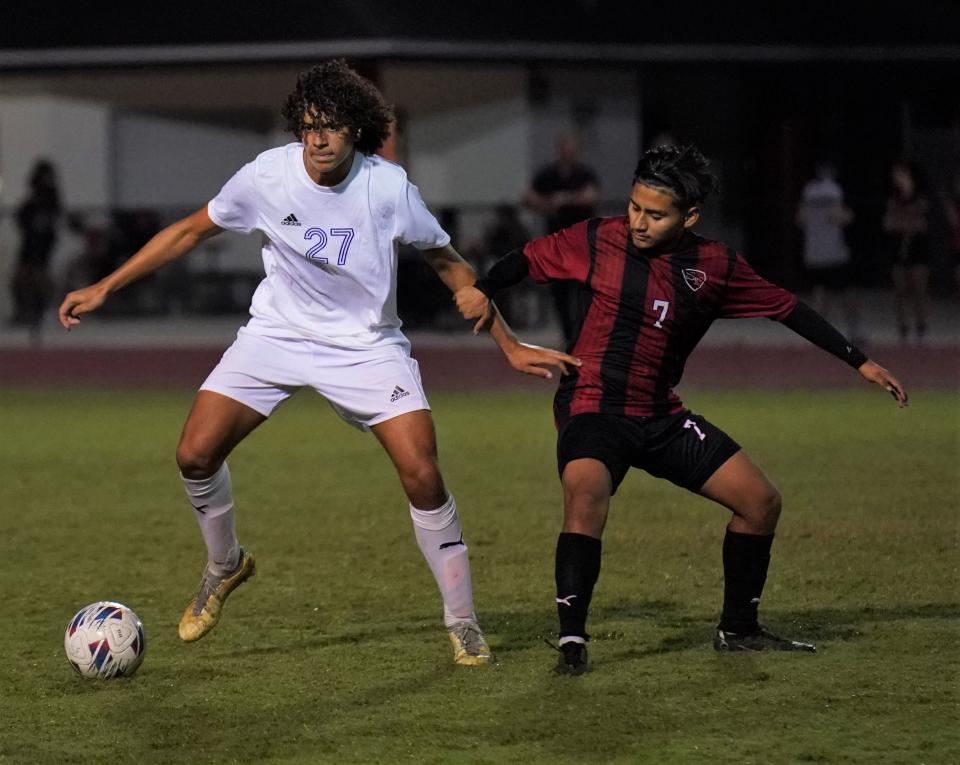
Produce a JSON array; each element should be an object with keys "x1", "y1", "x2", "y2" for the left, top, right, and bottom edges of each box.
[{"x1": 523, "y1": 216, "x2": 797, "y2": 422}]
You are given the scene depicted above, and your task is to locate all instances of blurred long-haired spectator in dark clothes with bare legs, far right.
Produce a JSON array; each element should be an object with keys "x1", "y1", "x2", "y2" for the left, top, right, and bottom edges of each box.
[{"x1": 883, "y1": 162, "x2": 930, "y2": 342}]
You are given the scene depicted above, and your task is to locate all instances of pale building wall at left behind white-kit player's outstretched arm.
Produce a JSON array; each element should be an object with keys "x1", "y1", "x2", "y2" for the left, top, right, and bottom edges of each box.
[{"x1": 0, "y1": 96, "x2": 269, "y2": 319}]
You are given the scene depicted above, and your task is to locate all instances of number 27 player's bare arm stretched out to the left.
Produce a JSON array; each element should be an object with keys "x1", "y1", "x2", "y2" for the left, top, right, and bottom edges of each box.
[{"x1": 59, "y1": 206, "x2": 223, "y2": 330}]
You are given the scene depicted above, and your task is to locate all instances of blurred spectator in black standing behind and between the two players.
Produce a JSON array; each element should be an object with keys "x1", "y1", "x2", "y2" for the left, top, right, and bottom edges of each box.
[{"x1": 523, "y1": 135, "x2": 600, "y2": 346}]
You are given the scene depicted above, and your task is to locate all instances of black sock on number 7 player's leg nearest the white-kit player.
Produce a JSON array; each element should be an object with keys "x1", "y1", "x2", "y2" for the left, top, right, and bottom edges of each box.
[{"x1": 556, "y1": 533, "x2": 600, "y2": 640}]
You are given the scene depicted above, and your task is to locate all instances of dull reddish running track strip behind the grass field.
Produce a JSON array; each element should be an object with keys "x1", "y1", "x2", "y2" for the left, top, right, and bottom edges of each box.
[{"x1": 0, "y1": 346, "x2": 960, "y2": 393}]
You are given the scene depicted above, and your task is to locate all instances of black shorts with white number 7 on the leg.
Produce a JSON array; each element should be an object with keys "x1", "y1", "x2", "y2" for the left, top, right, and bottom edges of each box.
[{"x1": 557, "y1": 409, "x2": 740, "y2": 495}]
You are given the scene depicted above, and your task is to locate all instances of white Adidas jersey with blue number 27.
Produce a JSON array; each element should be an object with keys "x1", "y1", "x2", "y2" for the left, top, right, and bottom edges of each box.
[{"x1": 207, "y1": 143, "x2": 450, "y2": 348}]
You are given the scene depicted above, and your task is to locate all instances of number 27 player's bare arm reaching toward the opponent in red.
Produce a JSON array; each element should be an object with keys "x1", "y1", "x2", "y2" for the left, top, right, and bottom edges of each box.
[{"x1": 423, "y1": 245, "x2": 580, "y2": 380}]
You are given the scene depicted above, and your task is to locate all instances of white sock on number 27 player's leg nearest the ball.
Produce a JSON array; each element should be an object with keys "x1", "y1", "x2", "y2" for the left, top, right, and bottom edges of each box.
[{"x1": 180, "y1": 462, "x2": 240, "y2": 575}]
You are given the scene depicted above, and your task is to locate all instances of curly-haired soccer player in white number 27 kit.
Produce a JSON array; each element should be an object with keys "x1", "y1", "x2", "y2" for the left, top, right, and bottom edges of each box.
[{"x1": 60, "y1": 60, "x2": 578, "y2": 665}]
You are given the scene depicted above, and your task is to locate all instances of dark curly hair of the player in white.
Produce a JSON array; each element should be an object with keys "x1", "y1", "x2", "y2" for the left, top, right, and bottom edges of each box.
[{"x1": 280, "y1": 58, "x2": 393, "y2": 154}]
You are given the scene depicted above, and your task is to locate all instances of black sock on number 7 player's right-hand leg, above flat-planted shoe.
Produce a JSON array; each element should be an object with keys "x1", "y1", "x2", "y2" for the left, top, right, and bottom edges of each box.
[{"x1": 717, "y1": 529, "x2": 773, "y2": 634}]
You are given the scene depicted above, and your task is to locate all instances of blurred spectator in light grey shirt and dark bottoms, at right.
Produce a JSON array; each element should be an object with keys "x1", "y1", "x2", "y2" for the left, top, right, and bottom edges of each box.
[{"x1": 796, "y1": 162, "x2": 862, "y2": 344}]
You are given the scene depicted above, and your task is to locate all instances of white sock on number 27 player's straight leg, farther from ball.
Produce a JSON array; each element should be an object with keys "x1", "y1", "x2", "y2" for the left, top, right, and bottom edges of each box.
[{"x1": 410, "y1": 494, "x2": 477, "y2": 627}]
